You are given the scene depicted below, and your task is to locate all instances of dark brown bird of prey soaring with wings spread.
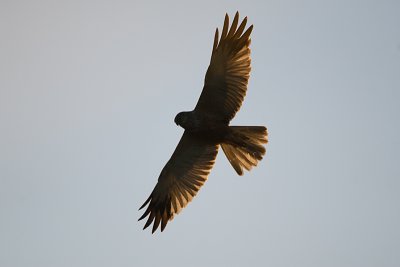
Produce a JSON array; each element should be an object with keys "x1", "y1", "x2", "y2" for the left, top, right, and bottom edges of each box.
[{"x1": 139, "y1": 12, "x2": 268, "y2": 233}]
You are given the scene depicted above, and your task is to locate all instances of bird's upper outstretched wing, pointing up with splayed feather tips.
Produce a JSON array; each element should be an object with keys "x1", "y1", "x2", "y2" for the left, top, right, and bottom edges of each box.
[{"x1": 195, "y1": 12, "x2": 253, "y2": 122}]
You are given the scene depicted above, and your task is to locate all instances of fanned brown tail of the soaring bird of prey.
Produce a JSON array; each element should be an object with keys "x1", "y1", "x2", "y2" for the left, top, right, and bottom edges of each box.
[{"x1": 221, "y1": 126, "x2": 268, "y2": 175}]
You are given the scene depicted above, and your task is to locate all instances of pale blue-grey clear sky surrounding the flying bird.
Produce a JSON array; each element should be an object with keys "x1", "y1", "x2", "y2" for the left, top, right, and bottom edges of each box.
[{"x1": 0, "y1": 0, "x2": 400, "y2": 267}]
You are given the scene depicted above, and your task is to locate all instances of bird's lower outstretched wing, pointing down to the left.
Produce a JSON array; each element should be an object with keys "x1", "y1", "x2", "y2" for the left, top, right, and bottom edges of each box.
[{"x1": 139, "y1": 132, "x2": 219, "y2": 233}]
